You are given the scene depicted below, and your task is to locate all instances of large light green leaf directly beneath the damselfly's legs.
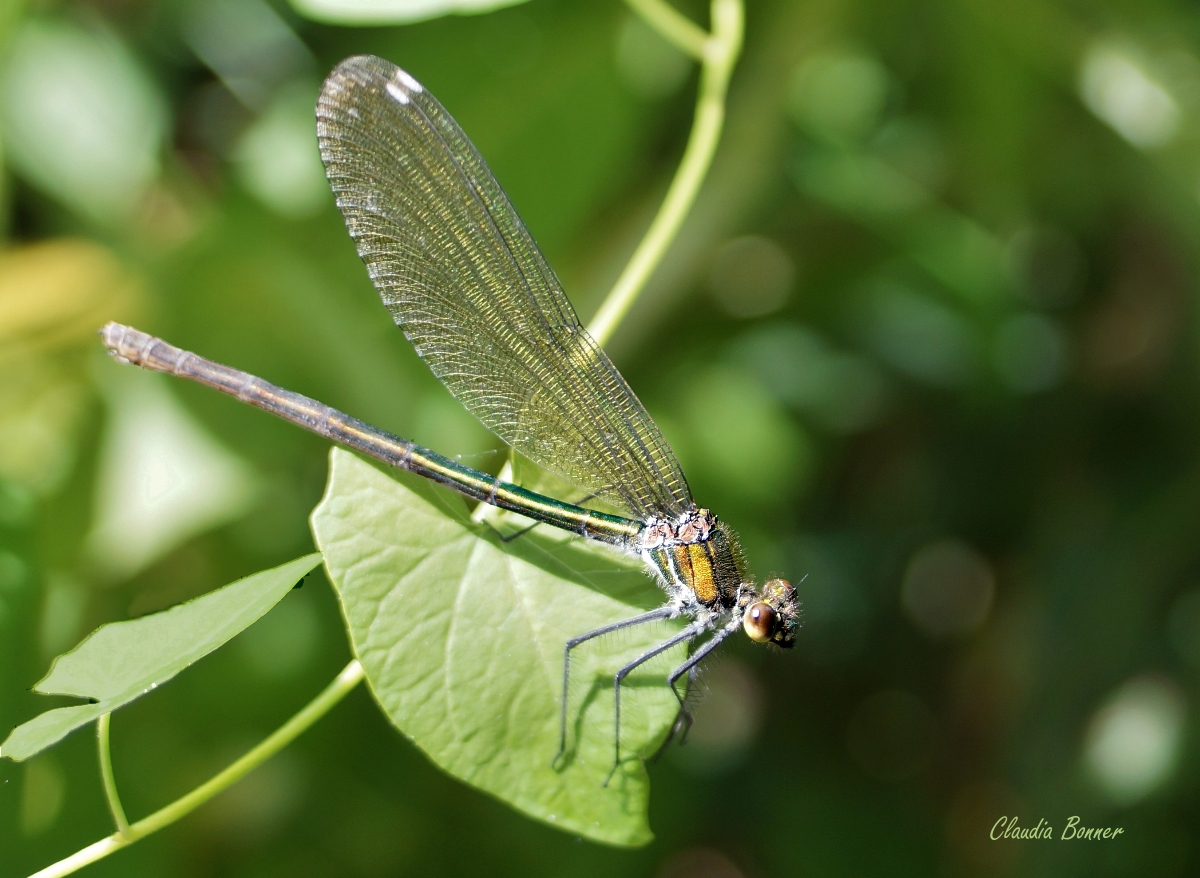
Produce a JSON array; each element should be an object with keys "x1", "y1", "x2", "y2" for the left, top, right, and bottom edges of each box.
[{"x1": 312, "y1": 449, "x2": 683, "y2": 846}]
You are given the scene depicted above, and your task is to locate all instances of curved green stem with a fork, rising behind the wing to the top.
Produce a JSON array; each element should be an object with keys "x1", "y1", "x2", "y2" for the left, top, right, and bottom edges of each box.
[{"x1": 588, "y1": 0, "x2": 743, "y2": 344}]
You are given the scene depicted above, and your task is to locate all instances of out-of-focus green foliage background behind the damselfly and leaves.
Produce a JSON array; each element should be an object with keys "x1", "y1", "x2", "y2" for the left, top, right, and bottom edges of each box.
[{"x1": 0, "y1": 0, "x2": 1200, "y2": 876}]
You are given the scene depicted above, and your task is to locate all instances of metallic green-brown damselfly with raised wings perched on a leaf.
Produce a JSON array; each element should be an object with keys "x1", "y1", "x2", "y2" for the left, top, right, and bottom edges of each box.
[{"x1": 101, "y1": 55, "x2": 800, "y2": 784}]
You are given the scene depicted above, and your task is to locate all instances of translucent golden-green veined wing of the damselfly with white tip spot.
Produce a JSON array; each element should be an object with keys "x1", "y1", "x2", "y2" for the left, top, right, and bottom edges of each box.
[{"x1": 317, "y1": 55, "x2": 694, "y2": 518}]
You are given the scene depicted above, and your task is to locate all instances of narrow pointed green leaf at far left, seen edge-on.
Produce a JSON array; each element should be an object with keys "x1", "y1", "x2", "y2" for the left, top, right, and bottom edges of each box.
[{"x1": 0, "y1": 553, "x2": 320, "y2": 762}]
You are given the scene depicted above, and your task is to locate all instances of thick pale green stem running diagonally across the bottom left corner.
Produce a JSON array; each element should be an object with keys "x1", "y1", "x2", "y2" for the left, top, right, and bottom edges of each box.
[{"x1": 30, "y1": 660, "x2": 362, "y2": 878}]
